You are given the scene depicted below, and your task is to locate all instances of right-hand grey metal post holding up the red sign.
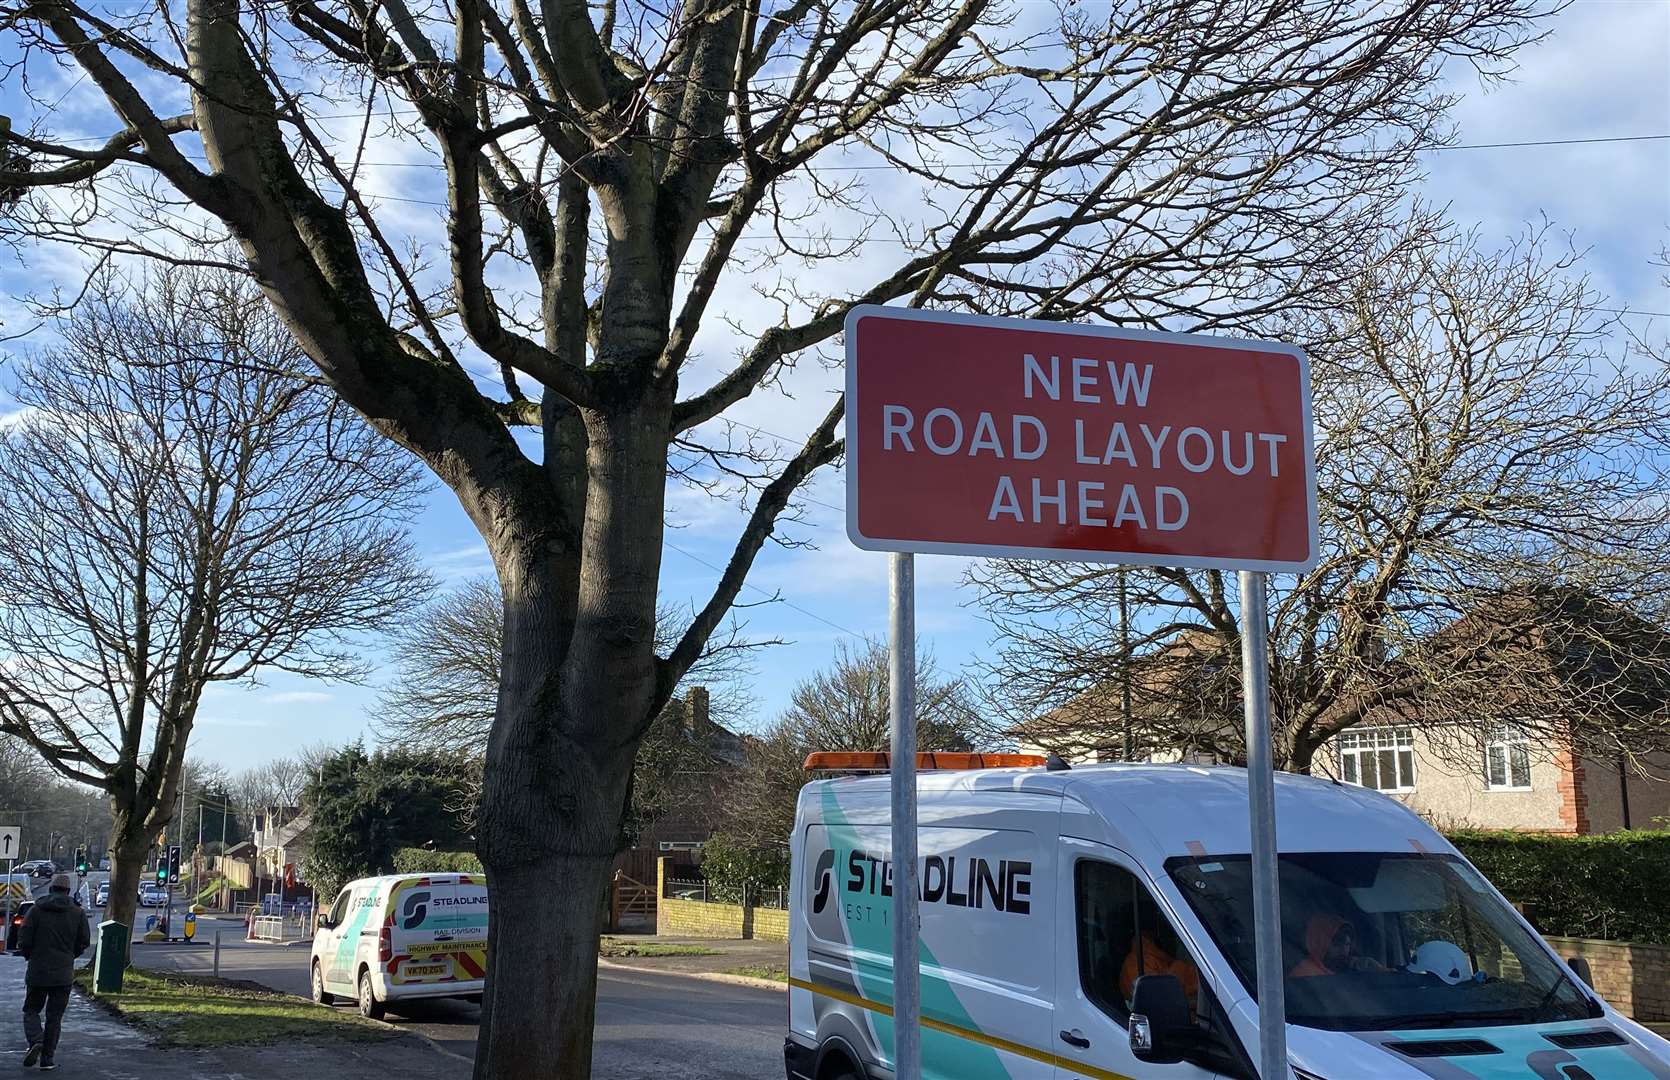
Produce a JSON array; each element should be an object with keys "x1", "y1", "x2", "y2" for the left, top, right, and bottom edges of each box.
[{"x1": 1241, "y1": 571, "x2": 1288, "y2": 1080}]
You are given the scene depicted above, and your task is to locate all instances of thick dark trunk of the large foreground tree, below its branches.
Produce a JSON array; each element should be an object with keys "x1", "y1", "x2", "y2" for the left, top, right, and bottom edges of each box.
[{"x1": 474, "y1": 530, "x2": 655, "y2": 1080}]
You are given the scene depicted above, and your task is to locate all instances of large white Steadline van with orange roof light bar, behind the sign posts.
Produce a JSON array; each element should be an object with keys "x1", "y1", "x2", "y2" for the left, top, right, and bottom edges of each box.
[{"x1": 785, "y1": 765, "x2": 1670, "y2": 1080}]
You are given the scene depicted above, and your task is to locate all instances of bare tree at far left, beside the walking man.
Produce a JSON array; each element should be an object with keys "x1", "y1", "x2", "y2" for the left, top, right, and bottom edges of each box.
[{"x1": 0, "y1": 270, "x2": 426, "y2": 925}]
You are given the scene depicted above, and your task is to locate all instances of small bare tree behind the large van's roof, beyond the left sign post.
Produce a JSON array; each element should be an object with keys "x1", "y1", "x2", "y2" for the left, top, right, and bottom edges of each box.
[{"x1": 720, "y1": 641, "x2": 980, "y2": 850}]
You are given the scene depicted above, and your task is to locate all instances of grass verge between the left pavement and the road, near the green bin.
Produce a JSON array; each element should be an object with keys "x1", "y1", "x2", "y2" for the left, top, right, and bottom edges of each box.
[{"x1": 75, "y1": 968, "x2": 399, "y2": 1050}]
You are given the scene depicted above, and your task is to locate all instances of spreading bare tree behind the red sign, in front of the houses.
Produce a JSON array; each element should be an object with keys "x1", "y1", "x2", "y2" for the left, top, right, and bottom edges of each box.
[{"x1": 974, "y1": 229, "x2": 1670, "y2": 771}]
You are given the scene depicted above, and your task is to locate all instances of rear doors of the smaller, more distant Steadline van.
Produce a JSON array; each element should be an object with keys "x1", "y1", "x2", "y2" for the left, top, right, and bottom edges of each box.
[{"x1": 386, "y1": 875, "x2": 488, "y2": 992}]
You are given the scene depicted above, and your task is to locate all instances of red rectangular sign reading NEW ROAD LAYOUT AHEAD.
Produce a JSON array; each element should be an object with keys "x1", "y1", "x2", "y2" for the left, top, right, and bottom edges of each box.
[{"x1": 847, "y1": 305, "x2": 1316, "y2": 571}]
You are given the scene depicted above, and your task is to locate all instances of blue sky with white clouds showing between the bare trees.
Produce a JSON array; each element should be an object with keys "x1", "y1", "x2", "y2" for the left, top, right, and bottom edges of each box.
[{"x1": 0, "y1": 0, "x2": 1670, "y2": 768}]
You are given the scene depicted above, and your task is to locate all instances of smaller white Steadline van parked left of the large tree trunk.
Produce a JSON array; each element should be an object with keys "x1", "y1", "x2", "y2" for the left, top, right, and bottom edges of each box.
[{"x1": 312, "y1": 873, "x2": 488, "y2": 1020}]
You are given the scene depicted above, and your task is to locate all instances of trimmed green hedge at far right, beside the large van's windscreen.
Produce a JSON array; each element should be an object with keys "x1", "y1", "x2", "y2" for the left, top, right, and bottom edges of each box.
[{"x1": 1450, "y1": 831, "x2": 1670, "y2": 945}]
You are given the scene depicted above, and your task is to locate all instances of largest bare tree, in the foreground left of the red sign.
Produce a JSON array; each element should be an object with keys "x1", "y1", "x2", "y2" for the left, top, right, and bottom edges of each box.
[{"x1": 0, "y1": 0, "x2": 1553, "y2": 1080}]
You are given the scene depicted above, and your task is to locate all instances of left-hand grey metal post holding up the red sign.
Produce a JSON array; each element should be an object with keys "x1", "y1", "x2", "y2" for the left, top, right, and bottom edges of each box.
[{"x1": 887, "y1": 551, "x2": 922, "y2": 1080}]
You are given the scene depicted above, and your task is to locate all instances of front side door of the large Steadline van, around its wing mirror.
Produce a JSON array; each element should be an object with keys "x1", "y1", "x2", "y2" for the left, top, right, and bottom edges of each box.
[{"x1": 1054, "y1": 836, "x2": 1247, "y2": 1080}]
